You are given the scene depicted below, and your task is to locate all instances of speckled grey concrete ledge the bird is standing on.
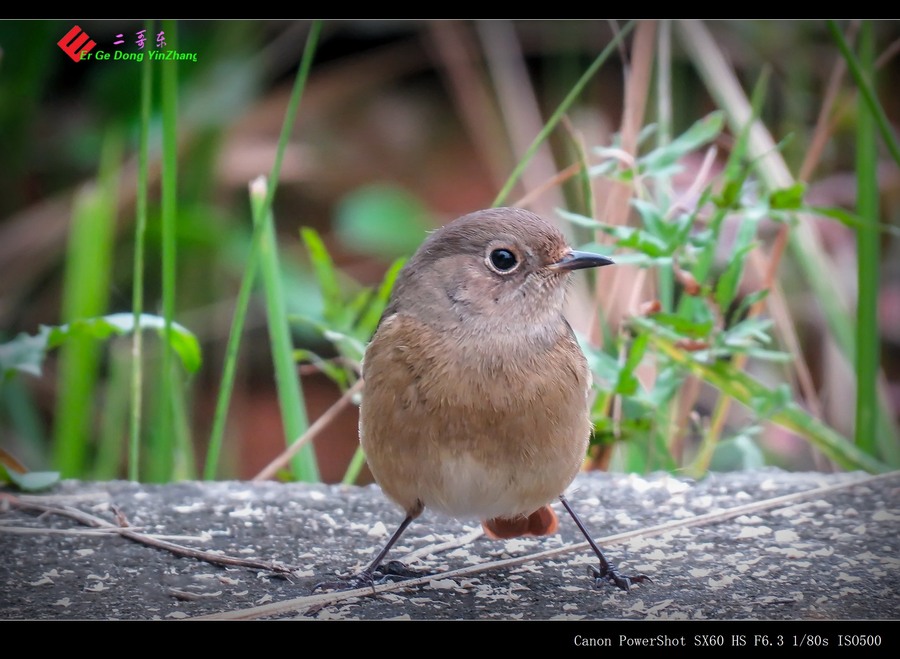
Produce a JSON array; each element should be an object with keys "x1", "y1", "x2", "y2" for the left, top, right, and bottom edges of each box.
[{"x1": 0, "y1": 470, "x2": 900, "y2": 621}]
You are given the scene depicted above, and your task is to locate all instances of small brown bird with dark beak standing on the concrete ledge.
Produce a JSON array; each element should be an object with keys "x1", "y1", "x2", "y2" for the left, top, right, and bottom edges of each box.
[{"x1": 320, "y1": 208, "x2": 649, "y2": 590}]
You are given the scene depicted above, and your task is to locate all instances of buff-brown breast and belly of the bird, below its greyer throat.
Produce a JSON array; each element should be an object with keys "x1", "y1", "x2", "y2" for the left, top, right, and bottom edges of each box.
[{"x1": 360, "y1": 315, "x2": 590, "y2": 519}]
